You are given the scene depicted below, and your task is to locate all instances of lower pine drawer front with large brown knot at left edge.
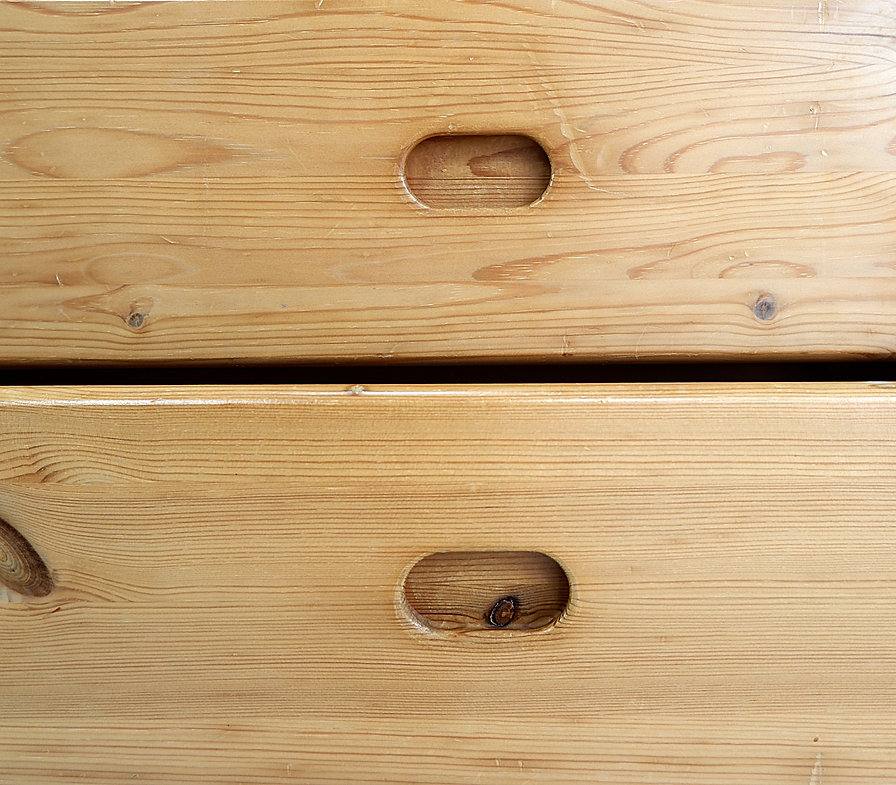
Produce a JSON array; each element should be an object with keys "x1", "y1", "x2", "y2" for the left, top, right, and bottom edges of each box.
[{"x1": 0, "y1": 384, "x2": 896, "y2": 785}]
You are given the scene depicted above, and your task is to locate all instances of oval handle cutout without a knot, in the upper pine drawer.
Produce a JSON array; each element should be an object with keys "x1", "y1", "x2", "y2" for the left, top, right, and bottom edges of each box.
[{"x1": 404, "y1": 135, "x2": 551, "y2": 209}]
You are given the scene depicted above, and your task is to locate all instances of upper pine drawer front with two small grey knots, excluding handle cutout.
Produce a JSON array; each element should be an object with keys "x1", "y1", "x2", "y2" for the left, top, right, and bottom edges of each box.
[{"x1": 0, "y1": 0, "x2": 896, "y2": 364}]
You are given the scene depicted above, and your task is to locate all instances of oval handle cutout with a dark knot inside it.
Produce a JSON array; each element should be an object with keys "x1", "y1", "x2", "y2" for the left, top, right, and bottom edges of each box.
[{"x1": 404, "y1": 551, "x2": 569, "y2": 632}]
